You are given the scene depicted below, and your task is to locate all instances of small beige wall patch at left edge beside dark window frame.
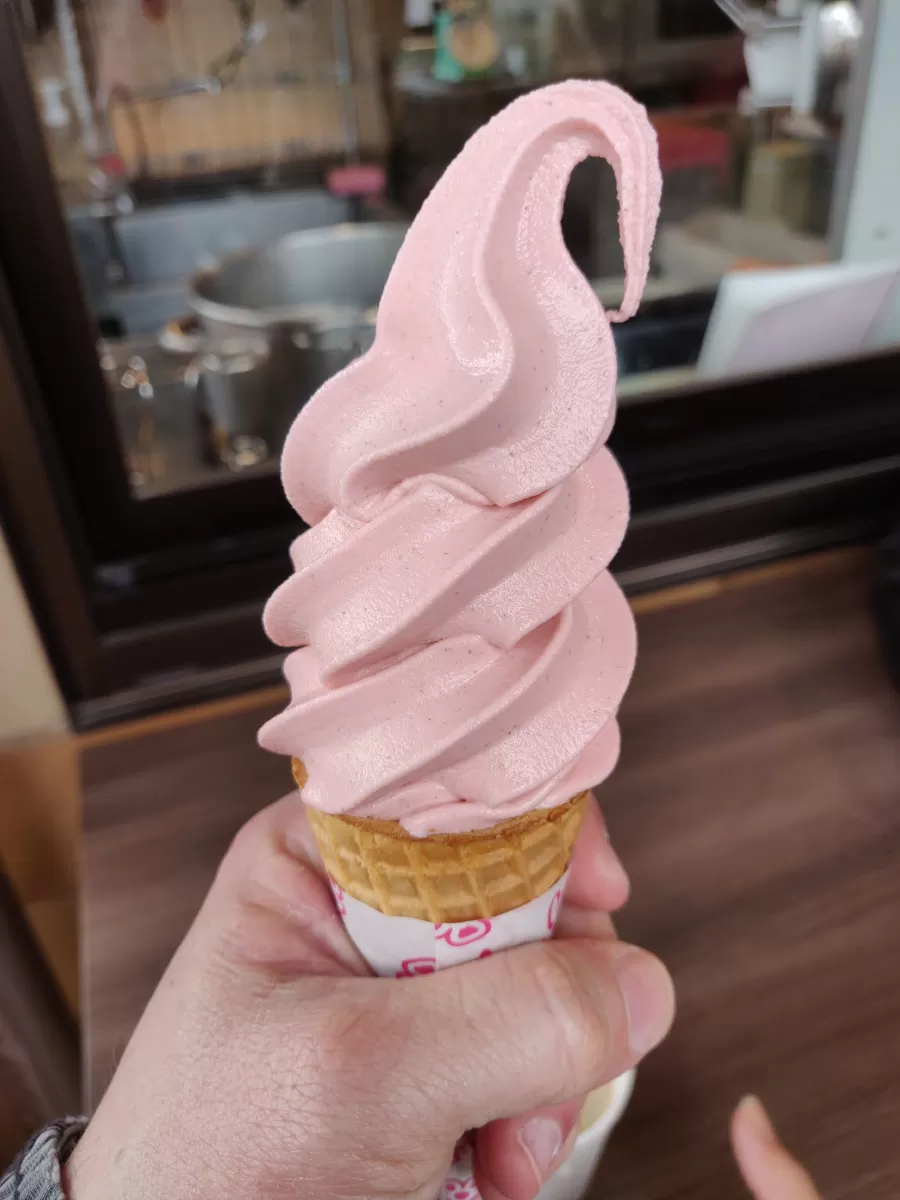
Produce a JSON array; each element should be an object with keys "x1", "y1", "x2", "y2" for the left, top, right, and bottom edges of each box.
[{"x1": 0, "y1": 533, "x2": 67, "y2": 745}]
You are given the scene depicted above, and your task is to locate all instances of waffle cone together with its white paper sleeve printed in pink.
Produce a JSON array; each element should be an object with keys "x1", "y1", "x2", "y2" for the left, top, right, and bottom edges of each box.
[{"x1": 293, "y1": 758, "x2": 589, "y2": 1200}]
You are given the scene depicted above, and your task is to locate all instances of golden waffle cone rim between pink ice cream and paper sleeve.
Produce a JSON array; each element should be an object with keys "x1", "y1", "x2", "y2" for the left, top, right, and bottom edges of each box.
[{"x1": 294, "y1": 758, "x2": 588, "y2": 923}]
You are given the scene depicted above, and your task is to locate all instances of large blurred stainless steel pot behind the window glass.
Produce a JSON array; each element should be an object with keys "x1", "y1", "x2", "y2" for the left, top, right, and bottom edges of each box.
[{"x1": 183, "y1": 222, "x2": 408, "y2": 446}]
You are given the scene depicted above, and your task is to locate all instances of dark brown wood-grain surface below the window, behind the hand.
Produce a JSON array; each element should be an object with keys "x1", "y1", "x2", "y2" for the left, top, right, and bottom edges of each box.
[{"x1": 83, "y1": 556, "x2": 900, "y2": 1200}]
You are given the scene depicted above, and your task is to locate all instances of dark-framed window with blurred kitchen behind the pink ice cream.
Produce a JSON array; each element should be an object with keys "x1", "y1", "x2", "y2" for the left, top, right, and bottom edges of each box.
[{"x1": 0, "y1": 0, "x2": 900, "y2": 725}]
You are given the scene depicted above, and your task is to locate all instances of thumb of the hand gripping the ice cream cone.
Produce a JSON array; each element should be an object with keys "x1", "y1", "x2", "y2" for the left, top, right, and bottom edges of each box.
[{"x1": 403, "y1": 938, "x2": 674, "y2": 1134}]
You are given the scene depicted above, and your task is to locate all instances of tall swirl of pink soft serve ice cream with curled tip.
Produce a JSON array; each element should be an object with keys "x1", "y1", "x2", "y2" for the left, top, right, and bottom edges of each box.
[{"x1": 259, "y1": 82, "x2": 660, "y2": 835}]
